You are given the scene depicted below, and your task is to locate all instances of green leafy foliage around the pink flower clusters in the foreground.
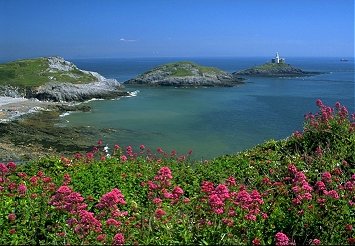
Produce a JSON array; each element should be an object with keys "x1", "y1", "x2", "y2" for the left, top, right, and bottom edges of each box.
[{"x1": 0, "y1": 99, "x2": 355, "y2": 245}]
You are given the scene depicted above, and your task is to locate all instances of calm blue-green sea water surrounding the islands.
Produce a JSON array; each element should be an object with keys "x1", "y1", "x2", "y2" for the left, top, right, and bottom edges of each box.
[{"x1": 63, "y1": 58, "x2": 355, "y2": 159}]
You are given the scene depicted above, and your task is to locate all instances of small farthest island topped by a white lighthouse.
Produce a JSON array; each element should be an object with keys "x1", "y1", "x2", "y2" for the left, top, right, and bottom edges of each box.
[{"x1": 233, "y1": 52, "x2": 321, "y2": 77}]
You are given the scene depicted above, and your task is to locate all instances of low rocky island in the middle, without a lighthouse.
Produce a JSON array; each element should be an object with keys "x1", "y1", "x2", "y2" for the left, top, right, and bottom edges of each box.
[{"x1": 125, "y1": 62, "x2": 243, "y2": 87}]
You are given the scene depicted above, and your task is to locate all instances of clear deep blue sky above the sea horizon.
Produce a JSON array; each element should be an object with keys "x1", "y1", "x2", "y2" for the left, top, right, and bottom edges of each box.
[{"x1": 0, "y1": 0, "x2": 354, "y2": 59}]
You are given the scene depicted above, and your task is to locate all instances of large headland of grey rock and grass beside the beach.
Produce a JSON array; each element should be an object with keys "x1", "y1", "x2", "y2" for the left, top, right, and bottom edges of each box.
[{"x1": 0, "y1": 56, "x2": 128, "y2": 102}]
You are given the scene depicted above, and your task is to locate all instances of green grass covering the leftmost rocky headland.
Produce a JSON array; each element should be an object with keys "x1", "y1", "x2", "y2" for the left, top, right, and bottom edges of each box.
[{"x1": 0, "y1": 58, "x2": 96, "y2": 87}]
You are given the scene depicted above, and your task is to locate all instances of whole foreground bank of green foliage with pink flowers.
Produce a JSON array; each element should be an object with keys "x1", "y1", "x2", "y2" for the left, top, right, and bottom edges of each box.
[{"x1": 0, "y1": 100, "x2": 355, "y2": 245}]
